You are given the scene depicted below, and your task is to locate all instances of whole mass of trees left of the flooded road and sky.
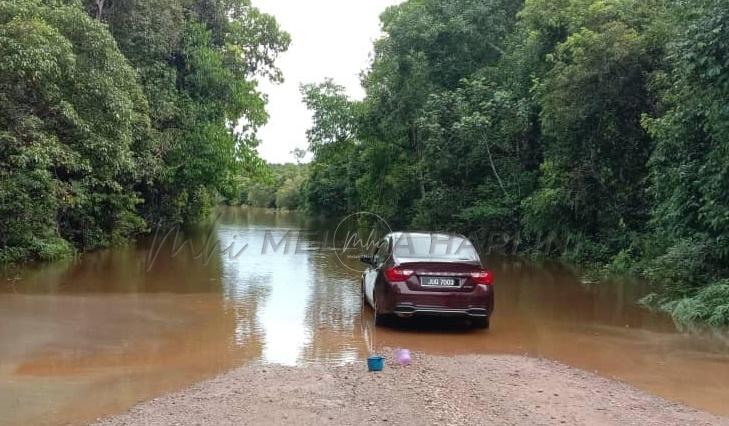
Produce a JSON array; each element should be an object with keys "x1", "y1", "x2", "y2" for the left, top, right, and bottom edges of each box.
[{"x1": 0, "y1": 0, "x2": 289, "y2": 263}]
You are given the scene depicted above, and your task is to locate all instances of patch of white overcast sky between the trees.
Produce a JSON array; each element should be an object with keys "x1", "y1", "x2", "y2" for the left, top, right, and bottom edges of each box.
[{"x1": 253, "y1": 0, "x2": 401, "y2": 163}]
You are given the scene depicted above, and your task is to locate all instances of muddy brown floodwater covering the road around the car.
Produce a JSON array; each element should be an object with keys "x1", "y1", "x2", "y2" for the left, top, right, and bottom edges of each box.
[{"x1": 0, "y1": 208, "x2": 729, "y2": 425}]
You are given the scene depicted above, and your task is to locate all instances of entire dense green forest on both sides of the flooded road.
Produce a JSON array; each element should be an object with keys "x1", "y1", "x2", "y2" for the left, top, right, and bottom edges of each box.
[{"x1": 0, "y1": 0, "x2": 729, "y2": 326}]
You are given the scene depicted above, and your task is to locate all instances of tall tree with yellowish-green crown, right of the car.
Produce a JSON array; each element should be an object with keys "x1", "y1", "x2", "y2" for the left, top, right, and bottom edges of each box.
[{"x1": 524, "y1": 2, "x2": 660, "y2": 262}]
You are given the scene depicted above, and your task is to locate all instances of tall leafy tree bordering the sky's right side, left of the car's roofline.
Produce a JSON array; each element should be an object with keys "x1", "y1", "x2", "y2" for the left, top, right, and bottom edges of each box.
[{"x1": 348, "y1": 0, "x2": 521, "y2": 226}]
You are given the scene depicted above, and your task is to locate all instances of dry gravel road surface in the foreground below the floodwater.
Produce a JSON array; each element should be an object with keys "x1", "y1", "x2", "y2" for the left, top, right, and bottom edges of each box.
[{"x1": 91, "y1": 354, "x2": 729, "y2": 426}]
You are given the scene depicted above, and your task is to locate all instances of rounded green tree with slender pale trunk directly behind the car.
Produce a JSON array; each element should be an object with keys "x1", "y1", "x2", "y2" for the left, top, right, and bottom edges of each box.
[{"x1": 413, "y1": 75, "x2": 534, "y2": 238}]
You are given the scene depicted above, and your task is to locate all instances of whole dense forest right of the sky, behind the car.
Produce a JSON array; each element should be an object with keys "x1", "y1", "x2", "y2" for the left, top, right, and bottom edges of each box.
[{"x1": 302, "y1": 0, "x2": 729, "y2": 325}]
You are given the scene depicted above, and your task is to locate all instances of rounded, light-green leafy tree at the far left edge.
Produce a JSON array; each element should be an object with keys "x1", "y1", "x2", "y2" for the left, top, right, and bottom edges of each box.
[{"x1": 0, "y1": 0, "x2": 150, "y2": 261}]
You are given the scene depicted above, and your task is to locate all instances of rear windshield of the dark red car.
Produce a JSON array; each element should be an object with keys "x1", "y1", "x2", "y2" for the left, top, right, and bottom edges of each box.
[{"x1": 393, "y1": 234, "x2": 479, "y2": 262}]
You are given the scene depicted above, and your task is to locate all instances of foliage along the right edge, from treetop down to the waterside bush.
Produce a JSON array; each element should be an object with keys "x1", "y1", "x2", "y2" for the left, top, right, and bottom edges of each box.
[{"x1": 644, "y1": 0, "x2": 729, "y2": 325}]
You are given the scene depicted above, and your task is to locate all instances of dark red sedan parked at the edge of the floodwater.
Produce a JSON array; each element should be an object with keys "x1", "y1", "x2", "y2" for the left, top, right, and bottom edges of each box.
[{"x1": 360, "y1": 232, "x2": 494, "y2": 328}]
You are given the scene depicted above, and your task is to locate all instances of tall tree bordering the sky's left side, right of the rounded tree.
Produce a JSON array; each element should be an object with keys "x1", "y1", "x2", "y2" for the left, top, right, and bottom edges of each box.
[{"x1": 89, "y1": 0, "x2": 290, "y2": 224}]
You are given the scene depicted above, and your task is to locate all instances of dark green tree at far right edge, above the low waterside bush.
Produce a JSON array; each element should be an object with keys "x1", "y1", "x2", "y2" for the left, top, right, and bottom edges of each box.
[{"x1": 645, "y1": 1, "x2": 729, "y2": 256}]
